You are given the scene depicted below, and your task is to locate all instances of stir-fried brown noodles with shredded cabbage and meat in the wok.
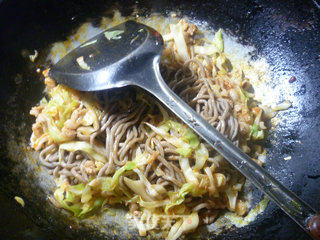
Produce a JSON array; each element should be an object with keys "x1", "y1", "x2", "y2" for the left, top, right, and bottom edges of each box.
[{"x1": 30, "y1": 15, "x2": 290, "y2": 239}]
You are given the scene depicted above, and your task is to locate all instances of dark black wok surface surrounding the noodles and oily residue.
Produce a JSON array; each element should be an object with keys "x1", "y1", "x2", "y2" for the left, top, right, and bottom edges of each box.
[{"x1": 0, "y1": 0, "x2": 320, "y2": 239}]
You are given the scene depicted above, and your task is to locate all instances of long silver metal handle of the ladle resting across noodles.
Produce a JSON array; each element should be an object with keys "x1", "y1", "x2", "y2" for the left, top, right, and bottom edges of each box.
[{"x1": 141, "y1": 55, "x2": 320, "y2": 240}]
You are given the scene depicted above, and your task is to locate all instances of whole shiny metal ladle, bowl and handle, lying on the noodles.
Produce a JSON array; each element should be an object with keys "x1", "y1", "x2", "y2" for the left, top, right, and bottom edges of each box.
[{"x1": 49, "y1": 21, "x2": 320, "y2": 239}]
